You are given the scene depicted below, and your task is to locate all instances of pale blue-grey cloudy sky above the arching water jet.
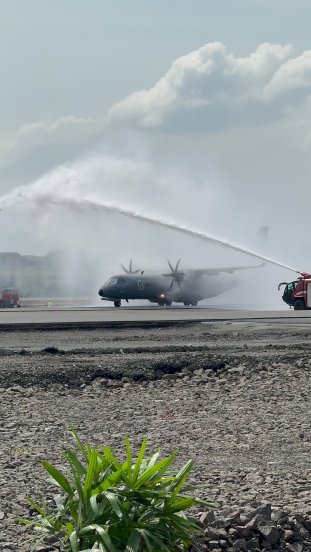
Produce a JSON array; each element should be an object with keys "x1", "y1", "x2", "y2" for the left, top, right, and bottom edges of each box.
[{"x1": 0, "y1": 0, "x2": 311, "y2": 300}]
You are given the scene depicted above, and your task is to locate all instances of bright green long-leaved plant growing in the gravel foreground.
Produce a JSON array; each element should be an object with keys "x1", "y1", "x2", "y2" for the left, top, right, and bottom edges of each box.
[{"x1": 19, "y1": 427, "x2": 211, "y2": 552}]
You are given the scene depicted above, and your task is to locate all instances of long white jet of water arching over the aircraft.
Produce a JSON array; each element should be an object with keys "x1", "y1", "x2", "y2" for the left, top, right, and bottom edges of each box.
[{"x1": 0, "y1": 192, "x2": 300, "y2": 274}]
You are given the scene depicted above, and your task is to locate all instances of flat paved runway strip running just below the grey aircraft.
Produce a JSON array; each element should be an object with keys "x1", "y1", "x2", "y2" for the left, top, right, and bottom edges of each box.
[{"x1": 0, "y1": 306, "x2": 311, "y2": 330}]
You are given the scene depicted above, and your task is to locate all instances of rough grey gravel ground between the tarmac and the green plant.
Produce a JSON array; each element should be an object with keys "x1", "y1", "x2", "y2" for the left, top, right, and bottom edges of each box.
[{"x1": 0, "y1": 323, "x2": 311, "y2": 552}]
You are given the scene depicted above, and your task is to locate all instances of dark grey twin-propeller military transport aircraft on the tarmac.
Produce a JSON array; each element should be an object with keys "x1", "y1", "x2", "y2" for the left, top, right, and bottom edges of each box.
[{"x1": 98, "y1": 259, "x2": 264, "y2": 307}]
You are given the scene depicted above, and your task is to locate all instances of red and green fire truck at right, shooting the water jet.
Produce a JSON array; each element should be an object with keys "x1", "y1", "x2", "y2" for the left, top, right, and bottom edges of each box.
[{"x1": 278, "y1": 272, "x2": 311, "y2": 310}]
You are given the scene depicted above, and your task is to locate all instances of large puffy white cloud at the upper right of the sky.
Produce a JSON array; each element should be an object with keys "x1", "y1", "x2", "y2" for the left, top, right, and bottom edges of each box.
[{"x1": 108, "y1": 42, "x2": 311, "y2": 130}]
